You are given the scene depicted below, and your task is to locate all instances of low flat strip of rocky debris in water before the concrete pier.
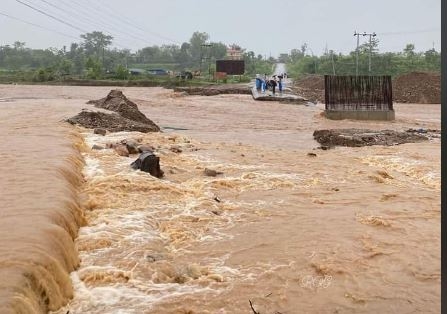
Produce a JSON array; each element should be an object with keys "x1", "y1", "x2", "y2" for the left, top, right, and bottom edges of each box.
[{"x1": 313, "y1": 129, "x2": 428, "y2": 147}]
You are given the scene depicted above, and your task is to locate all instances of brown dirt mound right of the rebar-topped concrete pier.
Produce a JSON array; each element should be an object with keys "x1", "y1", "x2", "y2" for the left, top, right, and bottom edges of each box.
[{"x1": 393, "y1": 72, "x2": 441, "y2": 104}]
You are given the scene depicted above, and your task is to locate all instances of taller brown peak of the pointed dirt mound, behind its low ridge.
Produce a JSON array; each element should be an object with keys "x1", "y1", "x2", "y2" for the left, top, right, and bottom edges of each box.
[{"x1": 87, "y1": 89, "x2": 160, "y2": 132}]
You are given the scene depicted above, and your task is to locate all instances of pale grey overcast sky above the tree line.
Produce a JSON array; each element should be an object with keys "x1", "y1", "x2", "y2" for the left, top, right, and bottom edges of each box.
[{"x1": 0, "y1": 0, "x2": 441, "y2": 57}]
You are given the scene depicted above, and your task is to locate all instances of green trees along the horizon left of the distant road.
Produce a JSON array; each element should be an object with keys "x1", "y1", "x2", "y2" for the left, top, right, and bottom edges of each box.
[{"x1": 0, "y1": 31, "x2": 271, "y2": 81}]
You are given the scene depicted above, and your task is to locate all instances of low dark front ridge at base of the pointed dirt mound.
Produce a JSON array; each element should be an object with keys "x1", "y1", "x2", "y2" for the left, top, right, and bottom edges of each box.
[{"x1": 66, "y1": 111, "x2": 159, "y2": 133}]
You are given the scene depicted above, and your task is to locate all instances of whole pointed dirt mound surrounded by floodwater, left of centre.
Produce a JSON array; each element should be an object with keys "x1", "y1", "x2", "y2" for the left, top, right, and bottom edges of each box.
[{"x1": 66, "y1": 90, "x2": 160, "y2": 133}]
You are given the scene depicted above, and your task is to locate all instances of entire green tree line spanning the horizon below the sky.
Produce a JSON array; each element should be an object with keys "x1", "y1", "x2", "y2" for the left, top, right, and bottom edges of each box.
[{"x1": 0, "y1": 31, "x2": 441, "y2": 82}]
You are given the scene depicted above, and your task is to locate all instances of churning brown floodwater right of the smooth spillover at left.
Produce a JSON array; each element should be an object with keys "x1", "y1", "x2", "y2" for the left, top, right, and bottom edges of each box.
[{"x1": 0, "y1": 87, "x2": 440, "y2": 313}]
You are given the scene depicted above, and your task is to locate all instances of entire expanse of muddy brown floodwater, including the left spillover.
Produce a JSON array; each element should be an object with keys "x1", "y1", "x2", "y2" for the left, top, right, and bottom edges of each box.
[{"x1": 0, "y1": 85, "x2": 441, "y2": 314}]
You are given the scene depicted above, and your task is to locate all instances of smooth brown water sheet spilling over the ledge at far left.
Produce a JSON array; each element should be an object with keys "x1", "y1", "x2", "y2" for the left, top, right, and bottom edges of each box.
[{"x1": 0, "y1": 114, "x2": 84, "y2": 313}]
